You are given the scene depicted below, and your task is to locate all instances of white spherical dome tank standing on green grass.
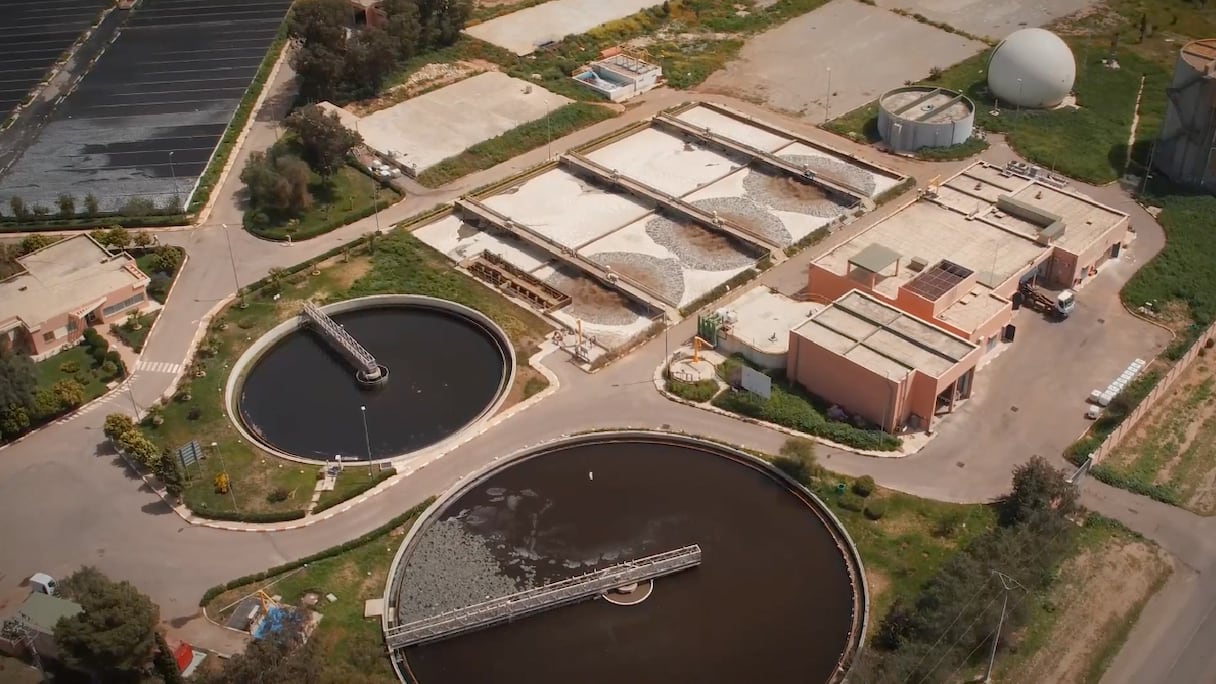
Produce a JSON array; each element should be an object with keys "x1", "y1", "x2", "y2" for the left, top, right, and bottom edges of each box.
[{"x1": 989, "y1": 28, "x2": 1076, "y2": 107}]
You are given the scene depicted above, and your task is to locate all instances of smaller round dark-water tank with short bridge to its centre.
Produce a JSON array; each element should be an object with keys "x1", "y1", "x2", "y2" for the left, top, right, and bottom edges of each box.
[{"x1": 227, "y1": 295, "x2": 514, "y2": 462}]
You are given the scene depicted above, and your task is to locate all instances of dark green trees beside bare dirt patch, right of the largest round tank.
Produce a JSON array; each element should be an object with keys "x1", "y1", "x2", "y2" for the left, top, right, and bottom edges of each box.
[{"x1": 850, "y1": 456, "x2": 1079, "y2": 684}]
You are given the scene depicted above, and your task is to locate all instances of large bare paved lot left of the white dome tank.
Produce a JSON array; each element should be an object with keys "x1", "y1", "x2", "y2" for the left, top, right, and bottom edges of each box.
[{"x1": 702, "y1": 0, "x2": 984, "y2": 123}]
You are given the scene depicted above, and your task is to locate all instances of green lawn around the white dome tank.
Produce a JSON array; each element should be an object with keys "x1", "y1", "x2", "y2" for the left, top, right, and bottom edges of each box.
[{"x1": 826, "y1": 41, "x2": 1169, "y2": 184}]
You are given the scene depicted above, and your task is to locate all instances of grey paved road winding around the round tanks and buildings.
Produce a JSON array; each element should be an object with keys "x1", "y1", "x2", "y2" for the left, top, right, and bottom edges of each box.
[{"x1": 0, "y1": 65, "x2": 1216, "y2": 683}]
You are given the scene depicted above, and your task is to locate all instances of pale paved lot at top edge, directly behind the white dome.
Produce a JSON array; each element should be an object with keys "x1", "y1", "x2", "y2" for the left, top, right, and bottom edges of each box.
[{"x1": 877, "y1": 0, "x2": 1096, "y2": 40}]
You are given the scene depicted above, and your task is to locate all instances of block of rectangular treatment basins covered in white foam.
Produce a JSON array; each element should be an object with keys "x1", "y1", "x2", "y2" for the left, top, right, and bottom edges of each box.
[{"x1": 416, "y1": 105, "x2": 903, "y2": 355}]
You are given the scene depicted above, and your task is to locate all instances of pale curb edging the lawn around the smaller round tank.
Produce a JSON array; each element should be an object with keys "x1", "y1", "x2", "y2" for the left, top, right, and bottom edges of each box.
[{"x1": 139, "y1": 338, "x2": 562, "y2": 532}]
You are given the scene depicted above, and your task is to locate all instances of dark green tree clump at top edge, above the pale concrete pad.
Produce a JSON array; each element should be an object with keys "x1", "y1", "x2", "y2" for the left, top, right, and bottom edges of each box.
[{"x1": 287, "y1": 0, "x2": 473, "y2": 102}]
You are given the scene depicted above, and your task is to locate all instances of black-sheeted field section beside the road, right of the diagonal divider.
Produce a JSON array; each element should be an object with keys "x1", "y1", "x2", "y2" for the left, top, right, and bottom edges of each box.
[{"x1": 0, "y1": 0, "x2": 291, "y2": 212}]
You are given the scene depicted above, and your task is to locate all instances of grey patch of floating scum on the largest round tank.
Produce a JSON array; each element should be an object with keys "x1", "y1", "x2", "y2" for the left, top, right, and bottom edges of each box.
[{"x1": 398, "y1": 518, "x2": 535, "y2": 622}]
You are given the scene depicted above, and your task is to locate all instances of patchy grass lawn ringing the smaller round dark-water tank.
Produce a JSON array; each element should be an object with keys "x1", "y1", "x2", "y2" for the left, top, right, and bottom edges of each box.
[{"x1": 138, "y1": 229, "x2": 551, "y2": 517}]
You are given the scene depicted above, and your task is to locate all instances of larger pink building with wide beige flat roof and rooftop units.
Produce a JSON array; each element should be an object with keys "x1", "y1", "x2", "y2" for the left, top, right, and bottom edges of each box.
[{"x1": 807, "y1": 162, "x2": 1128, "y2": 346}]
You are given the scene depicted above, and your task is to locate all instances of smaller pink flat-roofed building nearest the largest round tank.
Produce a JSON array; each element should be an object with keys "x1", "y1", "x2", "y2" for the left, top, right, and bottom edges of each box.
[{"x1": 786, "y1": 290, "x2": 983, "y2": 432}]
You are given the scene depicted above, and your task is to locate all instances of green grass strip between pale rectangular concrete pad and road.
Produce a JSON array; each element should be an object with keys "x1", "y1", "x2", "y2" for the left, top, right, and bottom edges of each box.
[{"x1": 418, "y1": 102, "x2": 617, "y2": 187}]
